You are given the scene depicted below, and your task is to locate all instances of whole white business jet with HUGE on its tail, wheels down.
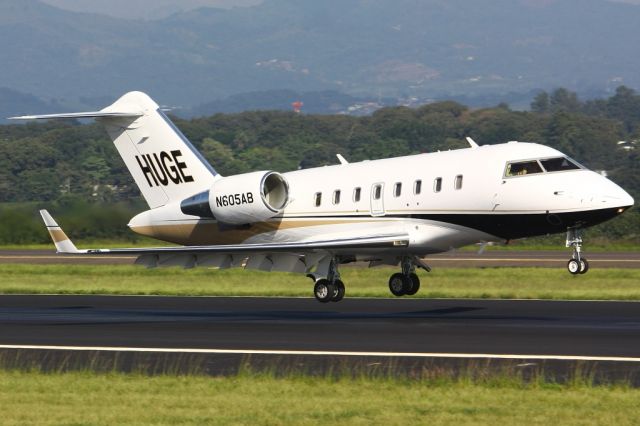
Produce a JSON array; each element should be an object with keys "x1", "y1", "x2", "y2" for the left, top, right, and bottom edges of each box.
[{"x1": 14, "y1": 92, "x2": 634, "y2": 302}]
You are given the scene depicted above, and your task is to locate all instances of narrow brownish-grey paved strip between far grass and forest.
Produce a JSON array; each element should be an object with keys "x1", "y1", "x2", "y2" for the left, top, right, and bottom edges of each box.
[{"x1": 0, "y1": 249, "x2": 640, "y2": 268}]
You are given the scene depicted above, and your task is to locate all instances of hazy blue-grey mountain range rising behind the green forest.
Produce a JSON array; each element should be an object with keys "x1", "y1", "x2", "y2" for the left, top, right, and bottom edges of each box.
[{"x1": 0, "y1": 0, "x2": 640, "y2": 108}]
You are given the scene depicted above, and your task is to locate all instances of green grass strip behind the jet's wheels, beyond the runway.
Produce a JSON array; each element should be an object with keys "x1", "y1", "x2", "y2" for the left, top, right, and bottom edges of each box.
[{"x1": 0, "y1": 264, "x2": 640, "y2": 300}]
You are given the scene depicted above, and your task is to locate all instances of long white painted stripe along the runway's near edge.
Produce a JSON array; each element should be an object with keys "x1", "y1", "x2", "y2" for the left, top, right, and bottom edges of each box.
[{"x1": 0, "y1": 345, "x2": 640, "y2": 362}]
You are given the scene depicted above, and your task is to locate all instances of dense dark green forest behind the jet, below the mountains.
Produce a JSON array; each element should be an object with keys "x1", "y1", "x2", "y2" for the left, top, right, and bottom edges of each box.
[{"x1": 0, "y1": 86, "x2": 640, "y2": 244}]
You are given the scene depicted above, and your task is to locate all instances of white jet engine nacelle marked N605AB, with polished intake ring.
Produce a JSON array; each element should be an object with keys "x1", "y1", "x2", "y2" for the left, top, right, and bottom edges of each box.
[{"x1": 180, "y1": 171, "x2": 289, "y2": 225}]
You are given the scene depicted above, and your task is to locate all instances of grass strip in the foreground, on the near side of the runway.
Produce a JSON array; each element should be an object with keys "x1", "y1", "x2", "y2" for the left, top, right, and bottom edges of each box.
[{"x1": 0, "y1": 371, "x2": 640, "y2": 426}]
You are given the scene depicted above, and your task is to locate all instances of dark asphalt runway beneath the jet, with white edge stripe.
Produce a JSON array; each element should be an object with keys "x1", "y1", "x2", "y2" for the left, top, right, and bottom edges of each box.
[{"x1": 0, "y1": 296, "x2": 640, "y2": 383}]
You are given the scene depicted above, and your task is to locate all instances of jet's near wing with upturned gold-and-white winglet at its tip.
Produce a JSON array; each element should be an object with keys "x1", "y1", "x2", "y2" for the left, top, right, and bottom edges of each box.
[{"x1": 40, "y1": 210, "x2": 409, "y2": 255}]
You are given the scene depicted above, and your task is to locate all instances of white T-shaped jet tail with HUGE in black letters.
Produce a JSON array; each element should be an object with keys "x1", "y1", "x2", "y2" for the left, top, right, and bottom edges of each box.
[{"x1": 12, "y1": 92, "x2": 217, "y2": 209}]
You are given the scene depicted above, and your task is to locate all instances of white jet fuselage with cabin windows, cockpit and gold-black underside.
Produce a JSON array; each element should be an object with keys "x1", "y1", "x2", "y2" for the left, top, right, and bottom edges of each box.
[{"x1": 129, "y1": 142, "x2": 633, "y2": 255}]
